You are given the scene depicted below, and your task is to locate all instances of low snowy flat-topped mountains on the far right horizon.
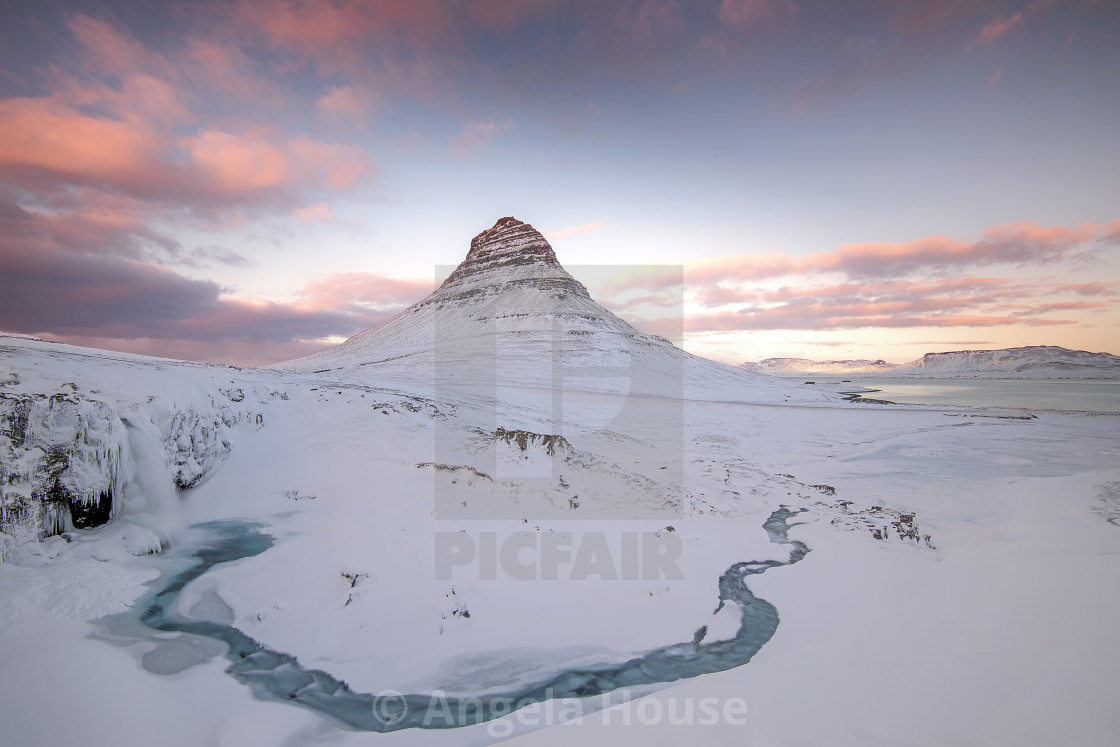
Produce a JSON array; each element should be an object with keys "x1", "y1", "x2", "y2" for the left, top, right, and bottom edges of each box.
[{"x1": 740, "y1": 345, "x2": 1120, "y2": 379}]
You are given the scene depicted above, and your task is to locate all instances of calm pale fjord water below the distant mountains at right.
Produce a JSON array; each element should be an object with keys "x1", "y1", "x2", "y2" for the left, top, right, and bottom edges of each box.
[{"x1": 833, "y1": 376, "x2": 1120, "y2": 412}]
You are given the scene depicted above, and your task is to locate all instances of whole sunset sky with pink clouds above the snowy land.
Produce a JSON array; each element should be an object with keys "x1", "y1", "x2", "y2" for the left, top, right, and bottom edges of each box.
[{"x1": 0, "y1": 0, "x2": 1120, "y2": 365}]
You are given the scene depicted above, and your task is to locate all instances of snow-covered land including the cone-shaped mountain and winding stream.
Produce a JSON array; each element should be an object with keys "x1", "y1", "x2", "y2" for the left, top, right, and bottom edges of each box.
[{"x1": 0, "y1": 218, "x2": 1120, "y2": 747}]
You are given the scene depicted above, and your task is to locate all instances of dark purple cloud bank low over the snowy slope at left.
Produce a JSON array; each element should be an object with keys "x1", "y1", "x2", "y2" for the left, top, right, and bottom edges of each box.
[{"x1": 0, "y1": 234, "x2": 412, "y2": 362}]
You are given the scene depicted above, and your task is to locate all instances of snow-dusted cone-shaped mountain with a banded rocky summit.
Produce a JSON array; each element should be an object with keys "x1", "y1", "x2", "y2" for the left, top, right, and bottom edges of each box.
[{"x1": 284, "y1": 212, "x2": 788, "y2": 400}]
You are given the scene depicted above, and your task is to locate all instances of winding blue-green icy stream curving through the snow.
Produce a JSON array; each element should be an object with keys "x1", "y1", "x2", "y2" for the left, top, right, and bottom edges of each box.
[{"x1": 124, "y1": 507, "x2": 809, "y2": 731}]
